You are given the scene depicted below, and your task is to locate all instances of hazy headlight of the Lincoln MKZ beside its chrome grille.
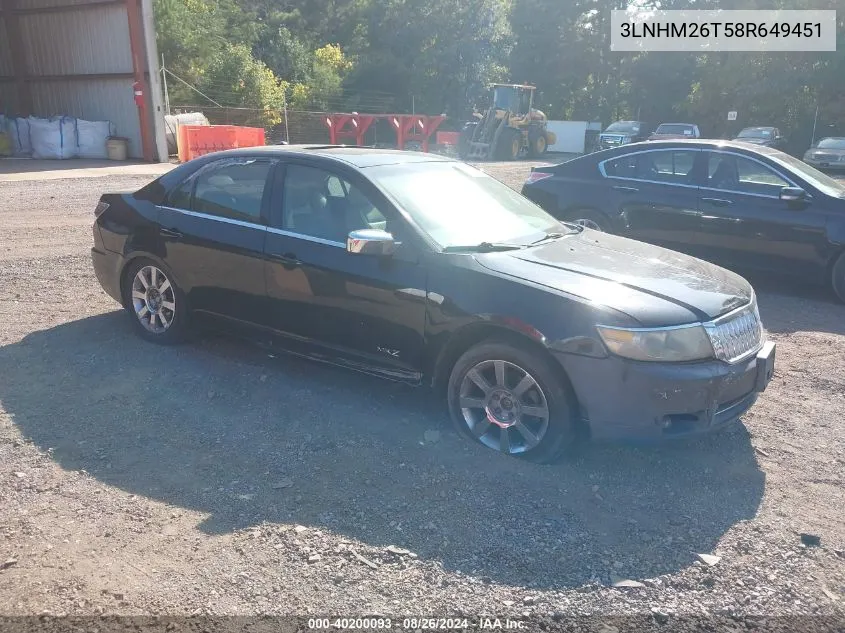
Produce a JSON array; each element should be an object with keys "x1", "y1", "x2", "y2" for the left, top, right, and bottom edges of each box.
[{"x1": 596, "y1": 324, "x2": 713, "y2": 362}]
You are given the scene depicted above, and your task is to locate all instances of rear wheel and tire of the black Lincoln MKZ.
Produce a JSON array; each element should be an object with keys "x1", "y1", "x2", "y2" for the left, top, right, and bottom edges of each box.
[{"x1": 123, "y1": 259, "x2": 188, "y2": 345}]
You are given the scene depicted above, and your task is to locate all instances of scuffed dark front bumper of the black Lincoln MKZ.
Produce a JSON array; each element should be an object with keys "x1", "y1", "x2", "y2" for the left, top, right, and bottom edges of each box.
[{"x1": 557, "y1": 342, "x2": 775, "y2": 440}]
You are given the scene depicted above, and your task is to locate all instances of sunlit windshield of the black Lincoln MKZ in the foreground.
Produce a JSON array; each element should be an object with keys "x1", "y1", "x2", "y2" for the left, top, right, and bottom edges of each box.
[{"x1": 367, "y1": 161, "x2": 571, "y2": 248}]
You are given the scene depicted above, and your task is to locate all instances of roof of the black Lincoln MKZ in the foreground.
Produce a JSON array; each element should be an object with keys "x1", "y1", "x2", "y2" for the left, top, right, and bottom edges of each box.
[{"x1": 193, "y1": 143, "x2": 454, "y2": 169}]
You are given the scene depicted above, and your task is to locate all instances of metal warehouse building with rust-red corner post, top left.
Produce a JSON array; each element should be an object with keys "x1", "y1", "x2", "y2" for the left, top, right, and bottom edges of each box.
[{"x1": 0, "y1": 0, "x2": 167, "y2": 162}]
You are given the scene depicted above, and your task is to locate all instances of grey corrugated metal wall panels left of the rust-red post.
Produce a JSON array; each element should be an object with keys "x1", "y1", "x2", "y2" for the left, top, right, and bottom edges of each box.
[{"x1": 0, "y1": 0, "x2": 142, "y2": 158}]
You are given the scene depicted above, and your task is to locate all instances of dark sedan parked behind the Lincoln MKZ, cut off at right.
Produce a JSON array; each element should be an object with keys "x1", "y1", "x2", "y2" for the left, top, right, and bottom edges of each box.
[{"x1": 522, "y1": 140, "x2": 845, "y2": 301}]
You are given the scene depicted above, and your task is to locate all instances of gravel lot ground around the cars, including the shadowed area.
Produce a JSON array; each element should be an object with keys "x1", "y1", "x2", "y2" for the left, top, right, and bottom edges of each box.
[{"x1": 0, "y1": 163, "x2": 845, "y2": 633}]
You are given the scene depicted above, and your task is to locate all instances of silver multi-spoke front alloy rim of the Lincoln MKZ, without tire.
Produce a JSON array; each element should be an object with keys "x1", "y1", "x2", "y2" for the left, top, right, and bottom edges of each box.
[{"x1": 459, "y1": 360, "x2": 549, "y2": 455}]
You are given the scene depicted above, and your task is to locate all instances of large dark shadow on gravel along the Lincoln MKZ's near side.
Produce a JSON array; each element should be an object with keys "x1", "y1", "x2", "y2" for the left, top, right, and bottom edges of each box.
[{"x1": 0, "y1": 312, "x2": 764, "y2": 588}]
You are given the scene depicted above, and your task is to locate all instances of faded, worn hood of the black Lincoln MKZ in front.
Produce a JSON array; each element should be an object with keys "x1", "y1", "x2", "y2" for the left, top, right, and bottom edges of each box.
[{"x1": 475, "y1": 229, "x2": 753, "y2": 327}]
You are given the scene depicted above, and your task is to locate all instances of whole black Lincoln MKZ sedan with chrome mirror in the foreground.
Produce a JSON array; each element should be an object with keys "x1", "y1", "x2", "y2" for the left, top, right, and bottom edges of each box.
[{"x1": 92, "y1": 146, "x2": 774, "y2": 462}]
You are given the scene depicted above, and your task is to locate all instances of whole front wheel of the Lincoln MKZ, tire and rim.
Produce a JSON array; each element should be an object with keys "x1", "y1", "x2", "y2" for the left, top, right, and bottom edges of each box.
[{"x1": 447, "y1": 341, "x2": 577, "y2": 464}]
